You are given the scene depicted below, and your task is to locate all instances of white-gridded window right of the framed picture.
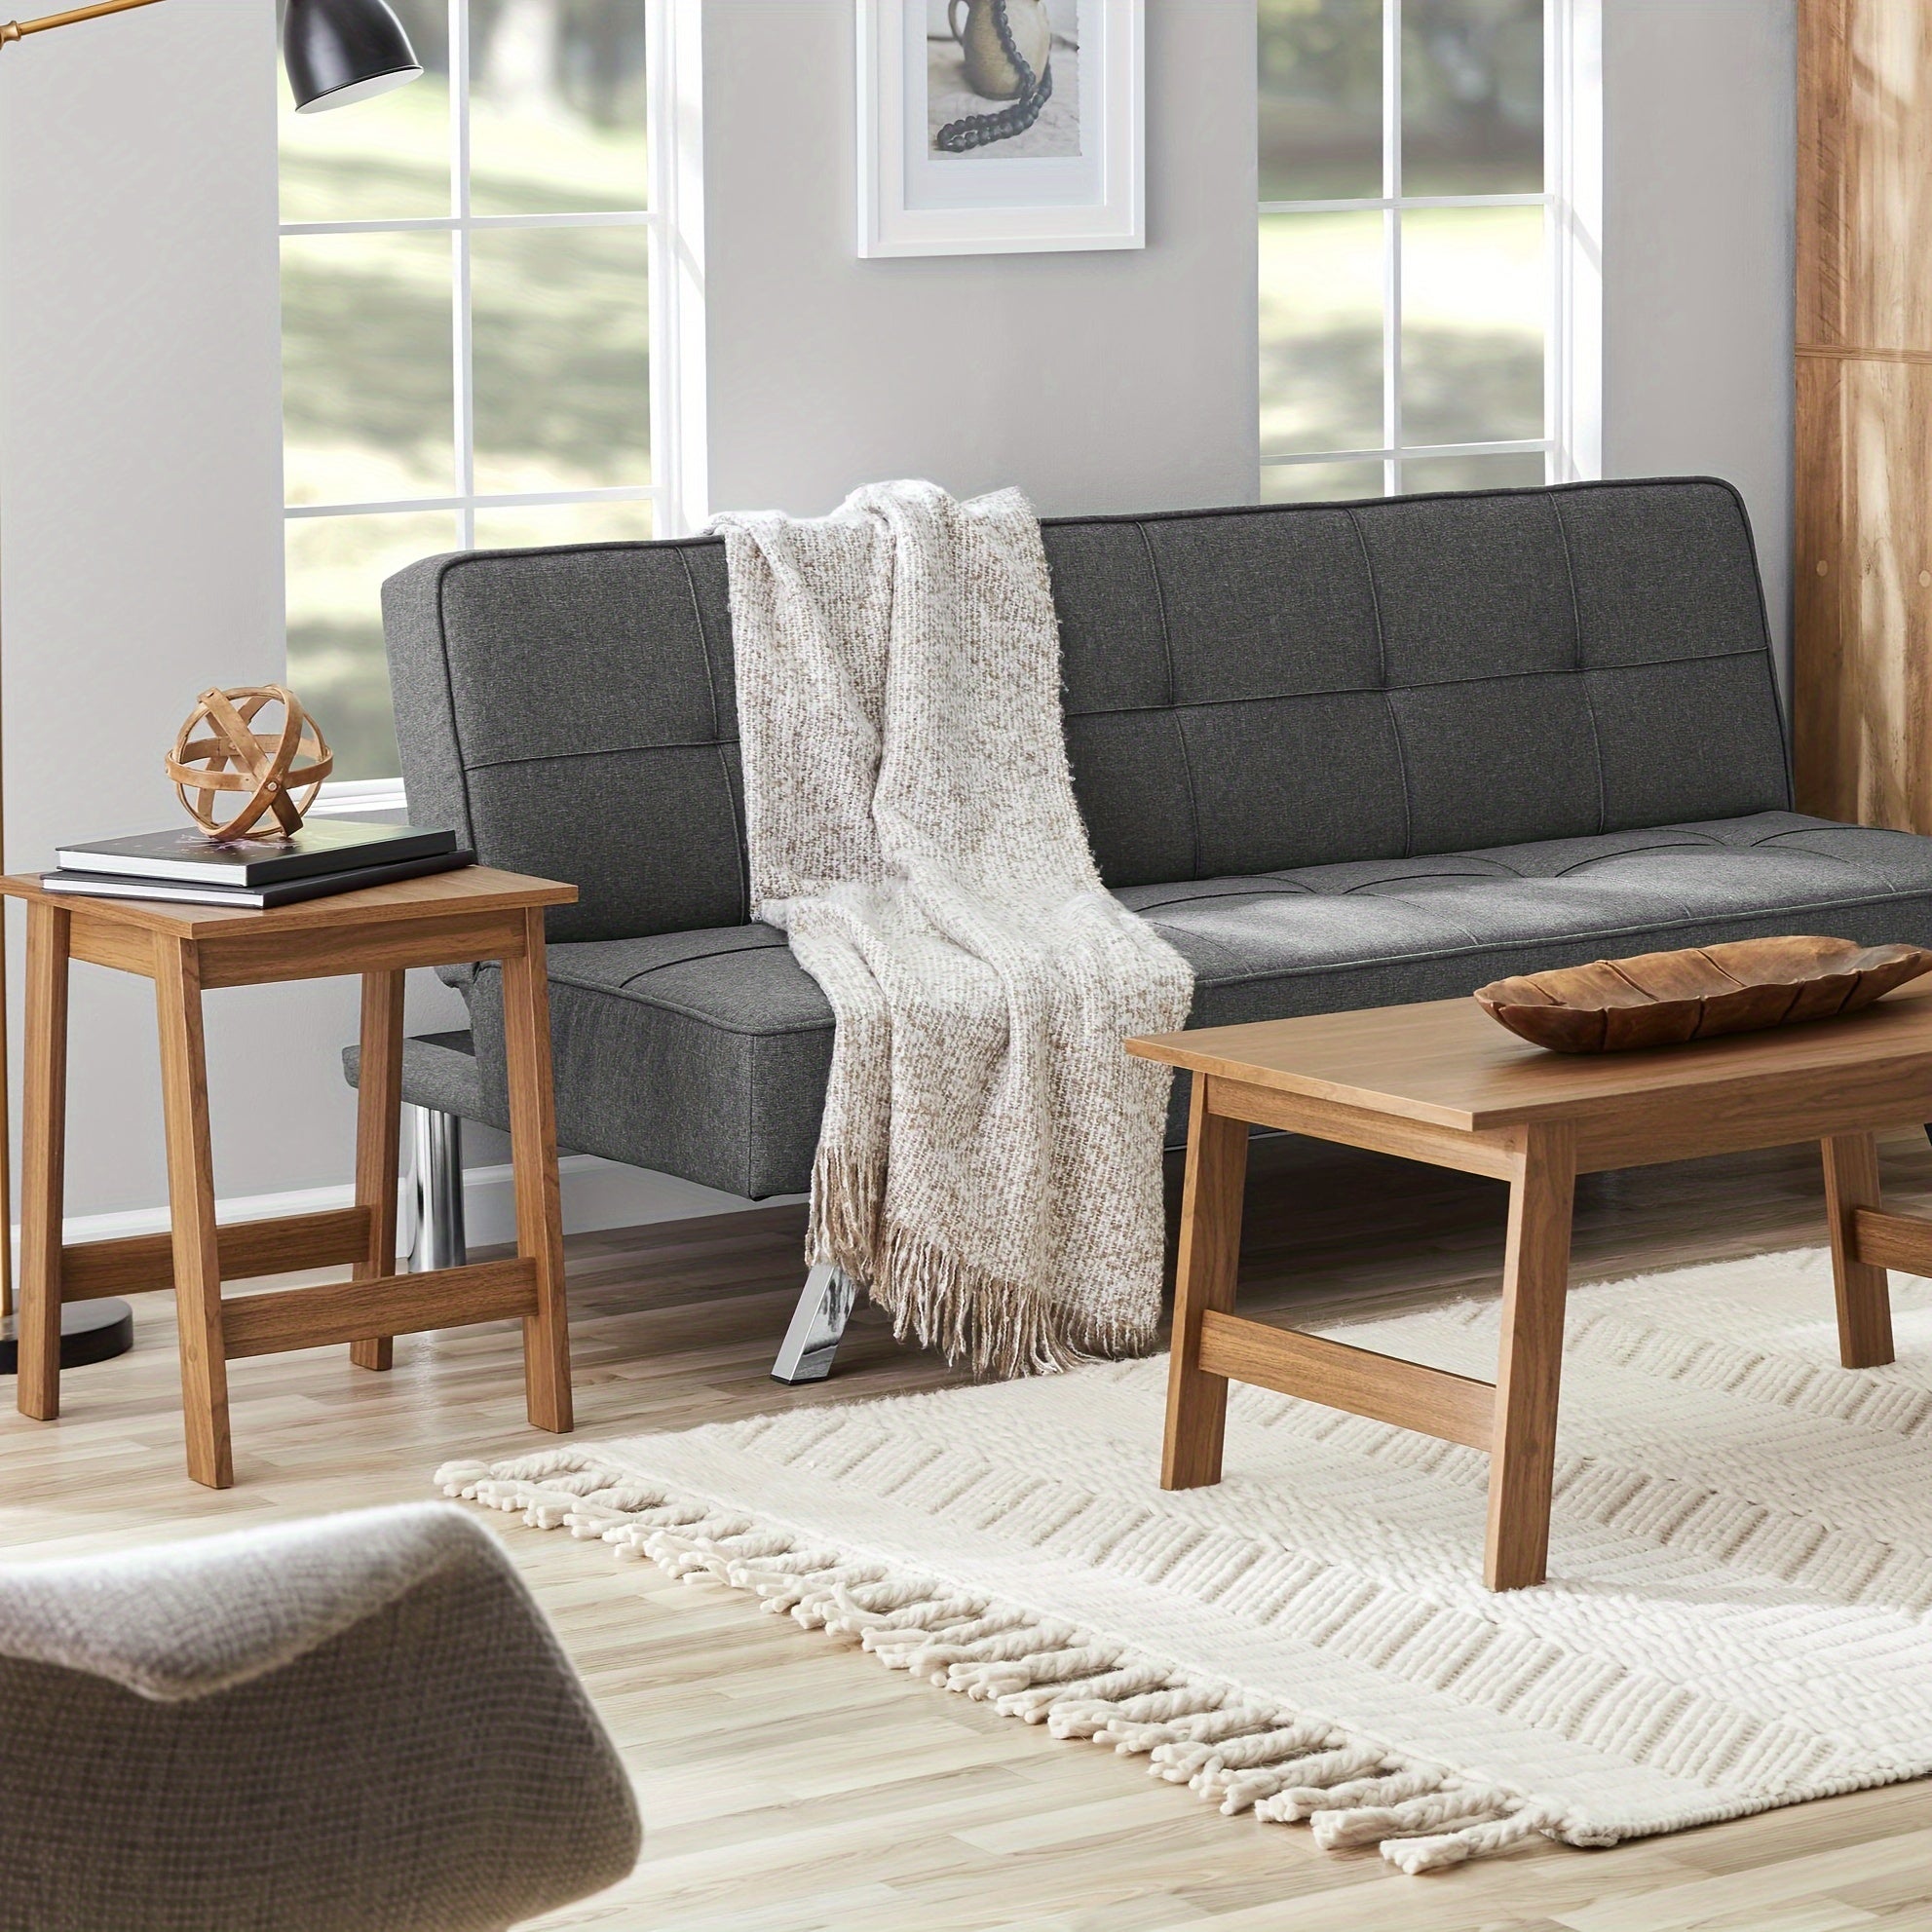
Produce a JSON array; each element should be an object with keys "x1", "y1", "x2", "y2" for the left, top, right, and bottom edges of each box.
[{"x1": 1258, "y1": 0, "x2": 1594, "y2": 503}]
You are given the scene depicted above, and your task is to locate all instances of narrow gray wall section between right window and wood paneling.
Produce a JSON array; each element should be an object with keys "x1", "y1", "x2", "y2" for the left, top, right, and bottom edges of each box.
[{"x1": 1604, "y1": 0, "x2": 1797, "y2": 687}]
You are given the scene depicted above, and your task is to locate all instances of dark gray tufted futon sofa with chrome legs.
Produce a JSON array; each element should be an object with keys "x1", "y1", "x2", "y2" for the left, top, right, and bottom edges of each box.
[{"x1": 350, "y1": 477, "x2": 1932, "y2": 1380}]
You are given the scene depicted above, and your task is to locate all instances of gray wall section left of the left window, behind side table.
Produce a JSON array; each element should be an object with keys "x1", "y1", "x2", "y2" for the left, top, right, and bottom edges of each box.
[{"x1": 0, "y1": 0, "x2": 370, "y2": 1211}]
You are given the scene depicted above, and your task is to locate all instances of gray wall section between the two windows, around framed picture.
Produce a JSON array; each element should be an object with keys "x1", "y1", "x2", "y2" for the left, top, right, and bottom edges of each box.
[{"x1": 703, "y1": 0, "x2": 1260, "y2": 511}]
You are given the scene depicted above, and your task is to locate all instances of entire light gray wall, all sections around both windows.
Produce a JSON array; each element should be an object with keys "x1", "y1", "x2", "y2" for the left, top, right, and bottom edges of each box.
[{"x1": 0, "y1": 0, "x2": 1793, "y2": 1211}]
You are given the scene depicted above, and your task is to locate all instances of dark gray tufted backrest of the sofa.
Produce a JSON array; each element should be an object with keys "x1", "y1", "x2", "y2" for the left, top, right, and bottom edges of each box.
[{"x1": 383, "y1": 477, "x2": 1789, "y2": 939}]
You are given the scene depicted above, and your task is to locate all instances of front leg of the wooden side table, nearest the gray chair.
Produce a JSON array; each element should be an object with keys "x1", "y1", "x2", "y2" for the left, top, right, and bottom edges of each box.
[{"x1": 155, "y1": 937, "x2": 236, "y2": 1490}]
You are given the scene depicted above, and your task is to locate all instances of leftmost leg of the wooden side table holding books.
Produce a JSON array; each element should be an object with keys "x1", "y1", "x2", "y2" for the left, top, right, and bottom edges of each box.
[{"x1": 18, "y1": 904, "x2": 73, "y2": 1421}]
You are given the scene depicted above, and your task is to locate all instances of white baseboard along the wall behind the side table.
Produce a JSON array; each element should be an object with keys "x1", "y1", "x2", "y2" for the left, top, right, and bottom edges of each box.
[{"x1": 24, "y1": 1154, "x2": 802, "y2": 1252}]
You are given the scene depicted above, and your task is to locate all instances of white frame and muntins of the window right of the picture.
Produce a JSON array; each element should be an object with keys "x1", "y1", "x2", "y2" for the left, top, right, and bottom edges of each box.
[{"x1": 1258, "y1": 0, "x2": 1604, "y2": 497}]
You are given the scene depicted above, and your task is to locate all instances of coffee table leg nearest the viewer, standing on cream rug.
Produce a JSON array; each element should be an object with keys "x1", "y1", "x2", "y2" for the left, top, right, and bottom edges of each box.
[{"x1": 1484, "y1": 1122, "x2": 1576, "y2": 1590}]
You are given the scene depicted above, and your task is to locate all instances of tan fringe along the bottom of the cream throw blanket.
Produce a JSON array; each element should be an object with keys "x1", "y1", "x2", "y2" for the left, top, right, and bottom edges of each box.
[{"x1": 806, "y1": 1146, "x2": 1159, "y2": 1382}]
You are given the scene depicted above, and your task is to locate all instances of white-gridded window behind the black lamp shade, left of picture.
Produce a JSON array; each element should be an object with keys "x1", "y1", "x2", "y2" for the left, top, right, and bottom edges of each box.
[{"x1": 281, "y1": 0, "x2": 664, "y2": 780}]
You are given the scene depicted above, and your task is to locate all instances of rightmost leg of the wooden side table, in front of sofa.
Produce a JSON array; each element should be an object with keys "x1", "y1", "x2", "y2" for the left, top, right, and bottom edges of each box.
[{"x1": 503, "y1": 910, "x2": 572, "y2": 1433}]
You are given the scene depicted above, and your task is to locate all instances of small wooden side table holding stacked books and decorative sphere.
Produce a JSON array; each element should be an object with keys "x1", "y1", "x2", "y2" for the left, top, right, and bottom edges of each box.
[{"x1": 0, "y1": 865, "x2": 578, "y2": 1490}]
